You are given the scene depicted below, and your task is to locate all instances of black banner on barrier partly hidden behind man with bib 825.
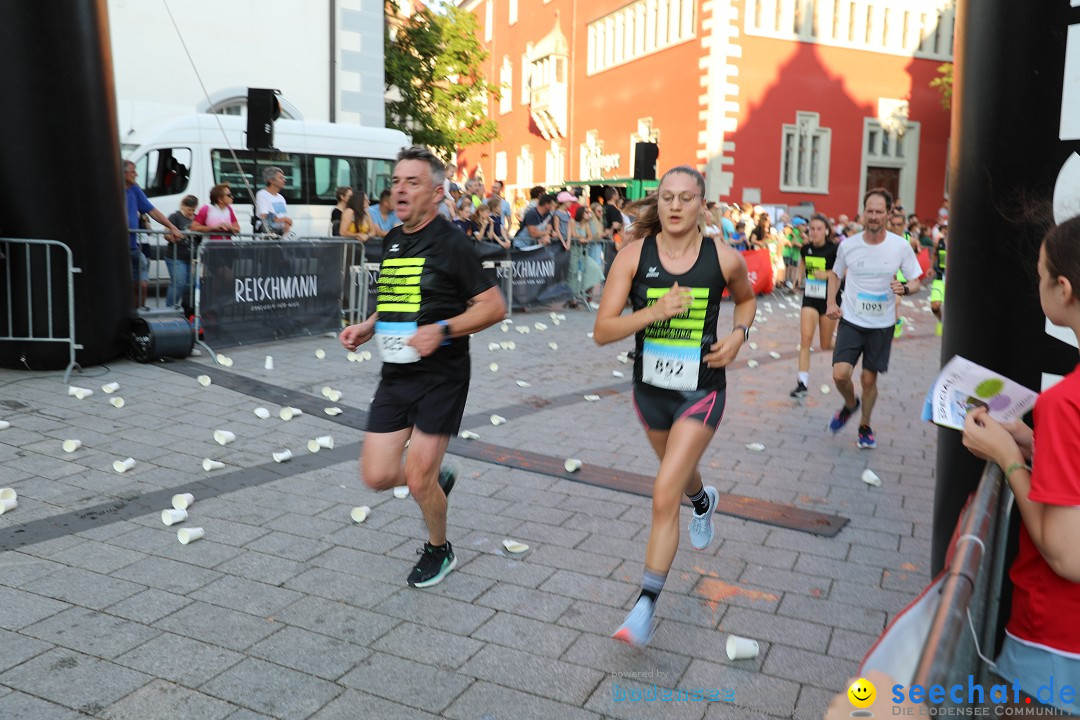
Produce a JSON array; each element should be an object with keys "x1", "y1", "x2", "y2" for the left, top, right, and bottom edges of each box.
[{"x1": 357, "y1": 240, "x2": 573, "y2": 314}]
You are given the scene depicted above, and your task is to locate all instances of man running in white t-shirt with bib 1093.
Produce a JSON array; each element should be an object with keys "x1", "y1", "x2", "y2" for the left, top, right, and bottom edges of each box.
[{"x1": 826, "y1": 188, "x2": 922, "y2": 449}]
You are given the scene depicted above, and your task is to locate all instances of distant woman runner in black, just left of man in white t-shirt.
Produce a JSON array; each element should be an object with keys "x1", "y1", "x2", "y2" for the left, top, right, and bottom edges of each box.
[{"x1": 792, "y1": 215, "x2": 838, "y2": 397}]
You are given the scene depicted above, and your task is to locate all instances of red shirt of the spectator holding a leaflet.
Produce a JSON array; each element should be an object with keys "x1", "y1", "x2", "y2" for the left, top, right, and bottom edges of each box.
[{"x1": 1005, "y1": 370, "x2": 1080, "y2": 654}]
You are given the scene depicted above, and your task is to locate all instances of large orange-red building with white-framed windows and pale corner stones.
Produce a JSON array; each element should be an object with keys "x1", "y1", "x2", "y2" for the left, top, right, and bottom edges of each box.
[{"x1": 458, "y1": 0, "x2": 954, "y2": 218}]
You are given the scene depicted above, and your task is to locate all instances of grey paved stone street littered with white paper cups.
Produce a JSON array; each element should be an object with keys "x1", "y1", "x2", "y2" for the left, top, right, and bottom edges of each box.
[{"x1": 0, "y1": 295, "x2": 940, "y2": 720}]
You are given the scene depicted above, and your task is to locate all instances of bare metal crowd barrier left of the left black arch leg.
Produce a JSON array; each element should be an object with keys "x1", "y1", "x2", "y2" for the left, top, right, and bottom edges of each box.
[{"x1": 0, "y1": 237, "x2": 82, "y2": 384}]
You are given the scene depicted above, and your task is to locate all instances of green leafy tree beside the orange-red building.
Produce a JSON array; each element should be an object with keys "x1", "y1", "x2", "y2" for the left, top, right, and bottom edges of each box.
[{"x1": 384, "y1": 5, "x2": 499, "y2": 158}]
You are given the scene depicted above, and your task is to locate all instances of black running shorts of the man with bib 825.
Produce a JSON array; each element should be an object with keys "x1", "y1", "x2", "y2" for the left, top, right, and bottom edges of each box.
[{"x1": 367, "y1": 372, "x2": 469, "y2": 435}]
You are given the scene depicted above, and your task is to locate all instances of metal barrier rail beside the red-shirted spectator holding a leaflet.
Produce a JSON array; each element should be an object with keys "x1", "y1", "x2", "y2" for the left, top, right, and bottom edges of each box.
[{"x1": 912, "y1": 463, "x2": 1013, "y2": 688}]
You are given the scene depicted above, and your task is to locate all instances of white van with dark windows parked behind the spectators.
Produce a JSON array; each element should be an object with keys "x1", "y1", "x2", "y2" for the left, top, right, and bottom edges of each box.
[{"x1": 130, "y1": 113, "x2": 410, "y2": 237}]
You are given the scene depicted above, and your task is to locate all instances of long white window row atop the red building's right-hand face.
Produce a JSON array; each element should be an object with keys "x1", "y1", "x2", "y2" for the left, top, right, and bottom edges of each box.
[{"x1": 743, "y1": 0, "x2": 956, "y2": 60}]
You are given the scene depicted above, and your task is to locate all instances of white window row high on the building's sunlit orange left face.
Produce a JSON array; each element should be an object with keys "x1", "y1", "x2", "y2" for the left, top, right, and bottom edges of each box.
[{"x1": 585, "y1": 0, "x2": 698, "y2": 74}]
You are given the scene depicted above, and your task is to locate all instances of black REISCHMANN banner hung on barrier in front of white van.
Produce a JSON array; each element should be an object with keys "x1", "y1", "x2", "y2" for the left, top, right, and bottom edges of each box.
[{"x1": 199, "y1": 241, "x2": 346, "y2": 349}]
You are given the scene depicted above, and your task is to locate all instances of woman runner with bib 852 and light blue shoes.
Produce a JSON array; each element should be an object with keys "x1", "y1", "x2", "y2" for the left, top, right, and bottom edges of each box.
[{"x1": 593, "y1": 165, "x2": 756, "y2": 647}]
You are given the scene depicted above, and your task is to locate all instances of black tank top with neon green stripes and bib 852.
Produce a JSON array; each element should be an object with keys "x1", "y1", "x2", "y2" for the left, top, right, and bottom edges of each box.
[{"x1": 630, "y1": 235, "x2": 727, "y2": 392}]
